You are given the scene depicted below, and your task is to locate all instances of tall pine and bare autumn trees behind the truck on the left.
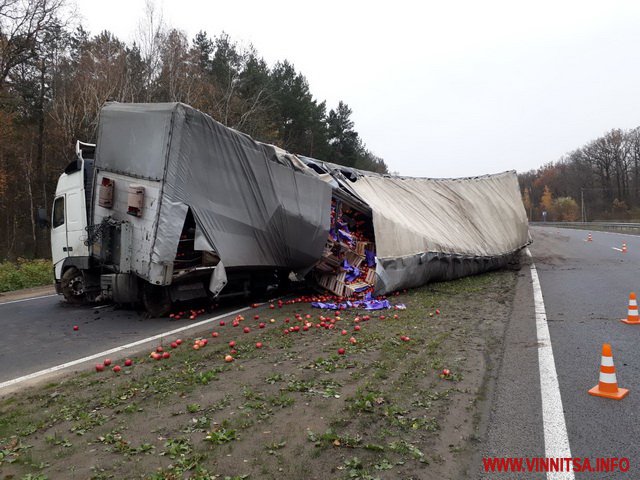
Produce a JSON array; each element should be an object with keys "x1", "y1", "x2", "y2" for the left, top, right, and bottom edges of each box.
[{"x1": 0, "y1": 0, "x2": 387, "y2": 260}]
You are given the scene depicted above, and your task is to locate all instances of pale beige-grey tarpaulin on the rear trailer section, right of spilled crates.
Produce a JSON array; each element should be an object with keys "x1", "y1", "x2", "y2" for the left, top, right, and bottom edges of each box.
[{"x1": 348, "y1": 171, "x2": 529, "y2": 293}]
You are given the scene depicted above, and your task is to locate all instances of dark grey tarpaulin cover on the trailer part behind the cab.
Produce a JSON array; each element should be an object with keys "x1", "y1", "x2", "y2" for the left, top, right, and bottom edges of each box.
[{"x1": 97, "y1": 103, "x2": 331, "y2": 276}]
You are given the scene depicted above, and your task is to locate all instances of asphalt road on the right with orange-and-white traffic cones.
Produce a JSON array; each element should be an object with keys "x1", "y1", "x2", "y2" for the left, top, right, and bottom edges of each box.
[{"x1": 530, "y1": 227, "x2": 640, "y2": 478}]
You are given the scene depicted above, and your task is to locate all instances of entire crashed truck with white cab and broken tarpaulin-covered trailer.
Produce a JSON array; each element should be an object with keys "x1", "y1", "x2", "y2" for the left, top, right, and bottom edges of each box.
[{"x1": 51, "y1": 103, "x2": 528, "y2": 314}]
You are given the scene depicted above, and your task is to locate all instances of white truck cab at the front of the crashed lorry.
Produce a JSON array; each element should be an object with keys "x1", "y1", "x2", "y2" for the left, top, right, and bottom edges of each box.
[{"x1": 51, "y1": 141, "x2": 95, "y2": 303}]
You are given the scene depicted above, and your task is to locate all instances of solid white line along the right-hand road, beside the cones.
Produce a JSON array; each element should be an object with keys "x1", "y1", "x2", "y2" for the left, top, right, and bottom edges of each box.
[{"x1": 527, "y1": 249, "x2": 575, "y2": 480}]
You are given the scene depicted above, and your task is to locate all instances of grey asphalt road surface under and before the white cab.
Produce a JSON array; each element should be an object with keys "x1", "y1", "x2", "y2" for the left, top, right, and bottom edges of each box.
[{"x1": 0, "y1": 295, "x2": 246, "y2": 384}]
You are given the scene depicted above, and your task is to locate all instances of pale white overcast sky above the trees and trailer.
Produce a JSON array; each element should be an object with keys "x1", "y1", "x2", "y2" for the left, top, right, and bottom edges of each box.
[{"x1": 72, "y1": 0, "x2": 640, "y2": 177}]
